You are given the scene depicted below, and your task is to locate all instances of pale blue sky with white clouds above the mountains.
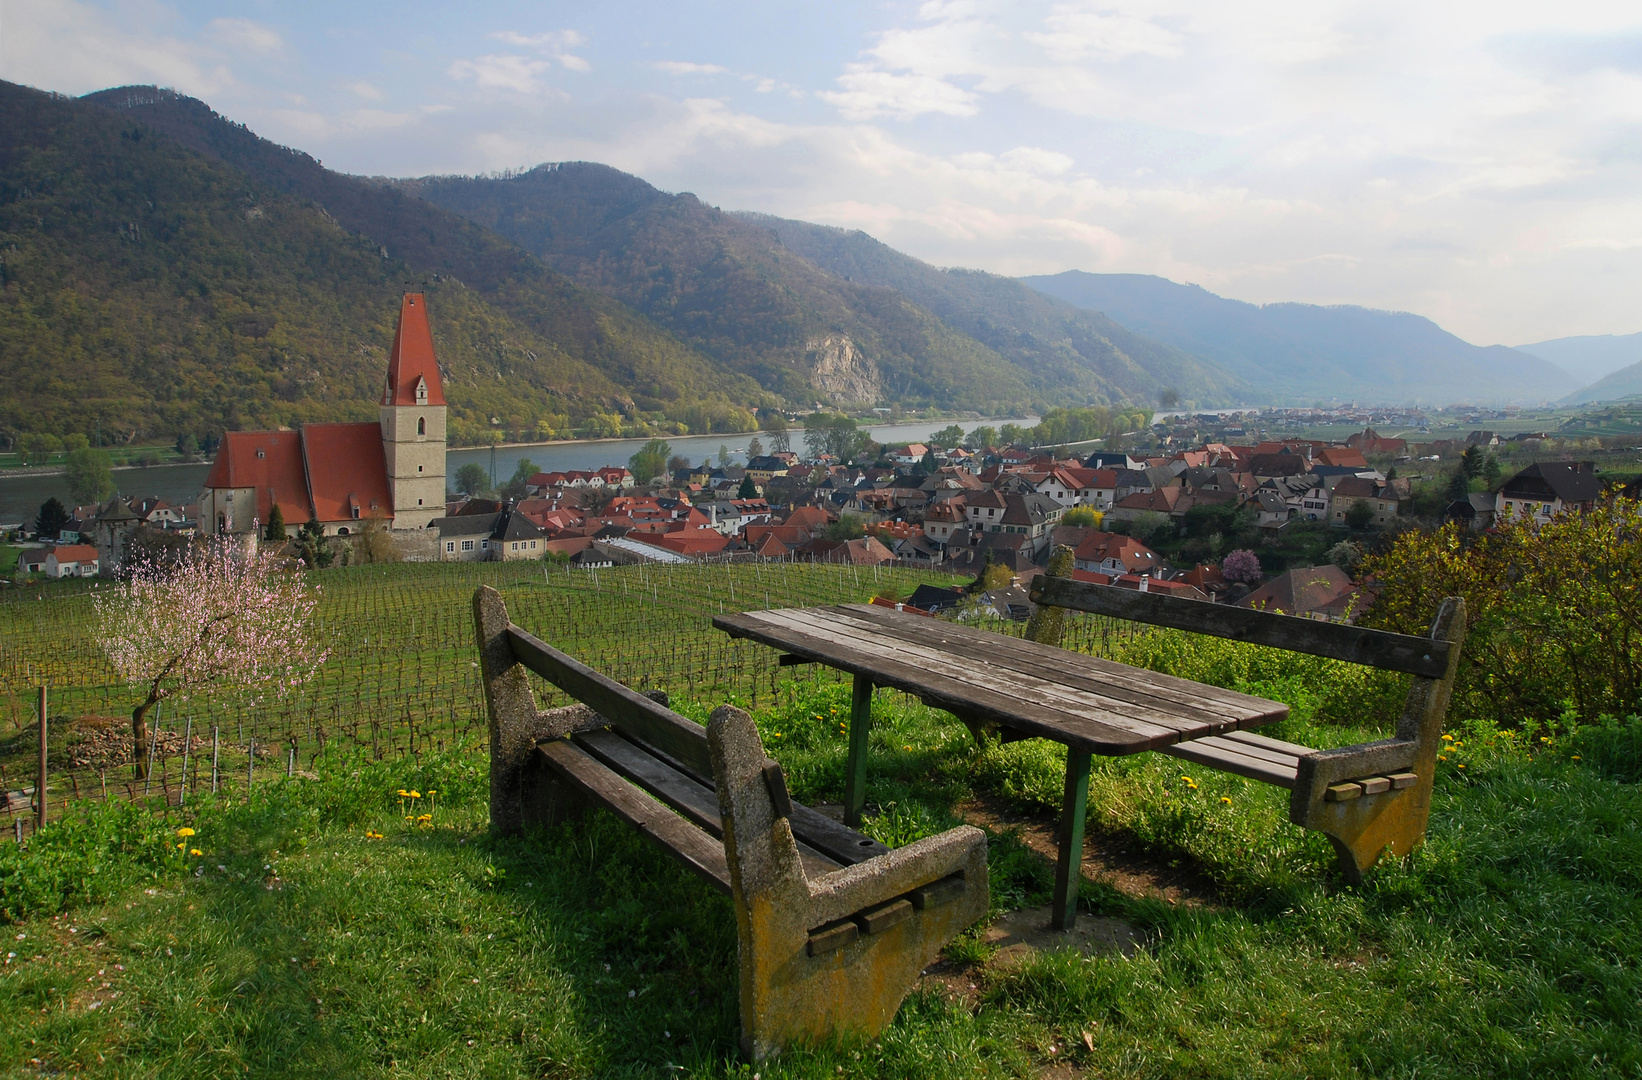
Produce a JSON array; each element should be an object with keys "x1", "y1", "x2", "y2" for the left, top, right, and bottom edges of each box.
[{"x1": 0, "y1": 0, "x2": 1642, "y2": 345}]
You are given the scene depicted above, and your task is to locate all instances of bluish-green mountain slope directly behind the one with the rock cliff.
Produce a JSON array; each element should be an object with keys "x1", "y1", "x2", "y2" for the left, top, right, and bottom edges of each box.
[{"x1": 736, "y1": 213, "x2": 1248, "y2": 405}]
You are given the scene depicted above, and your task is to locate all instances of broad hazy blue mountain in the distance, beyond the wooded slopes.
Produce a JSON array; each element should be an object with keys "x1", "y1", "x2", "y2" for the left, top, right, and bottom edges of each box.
[{"x1": 1021, "y1": 271, "x2": 1571, "y2": 404}]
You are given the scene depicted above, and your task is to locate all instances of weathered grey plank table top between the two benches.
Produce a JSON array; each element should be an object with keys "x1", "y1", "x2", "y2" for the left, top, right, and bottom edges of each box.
[{"x1": 713, "y1": 604, "x2": 1289, "y2": 755}]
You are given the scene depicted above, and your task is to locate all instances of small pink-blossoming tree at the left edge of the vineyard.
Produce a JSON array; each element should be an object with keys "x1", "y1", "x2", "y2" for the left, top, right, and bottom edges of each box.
[{"x1": 97, "y1": 542, "x2": 328, "y2": 780}]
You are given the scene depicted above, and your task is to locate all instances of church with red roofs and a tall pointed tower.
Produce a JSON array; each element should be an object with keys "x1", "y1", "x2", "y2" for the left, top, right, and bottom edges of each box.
[{"x1": 199, "y1": 292, "x2": 445, "y2": 537}]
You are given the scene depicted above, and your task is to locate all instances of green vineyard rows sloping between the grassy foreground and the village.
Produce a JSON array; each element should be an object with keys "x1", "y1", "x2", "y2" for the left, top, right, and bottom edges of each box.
[{"x1": 0, "y1": 563, "x2": 1142, "y2": 824}]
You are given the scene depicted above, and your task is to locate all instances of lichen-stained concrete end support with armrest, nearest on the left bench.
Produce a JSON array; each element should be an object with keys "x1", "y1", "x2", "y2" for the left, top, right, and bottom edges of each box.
[{"x1": 708, "y1": 706, "x2": 988, "y2": 1060}]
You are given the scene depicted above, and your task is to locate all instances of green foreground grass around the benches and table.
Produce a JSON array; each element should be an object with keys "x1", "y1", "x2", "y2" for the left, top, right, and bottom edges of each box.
[{"x1": 0, "y1": 681, "x2": 1642, "y2": 1078}]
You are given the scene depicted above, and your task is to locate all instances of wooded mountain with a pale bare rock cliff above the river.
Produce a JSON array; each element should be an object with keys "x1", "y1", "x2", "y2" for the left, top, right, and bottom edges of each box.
[{"x1": 402, "y1": 162, "x2": 1235, "y2": 412}]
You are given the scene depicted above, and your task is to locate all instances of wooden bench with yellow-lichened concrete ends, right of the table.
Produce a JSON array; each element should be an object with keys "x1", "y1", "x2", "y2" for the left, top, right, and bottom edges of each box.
[{"x1": 1028, "y1": 548, "x2": 1465, "y2": 883}]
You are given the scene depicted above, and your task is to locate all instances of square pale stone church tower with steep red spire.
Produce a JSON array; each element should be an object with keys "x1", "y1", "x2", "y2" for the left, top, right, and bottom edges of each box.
[{"x1": 381, "y1": 292, "x2": 445, "y2": 529}]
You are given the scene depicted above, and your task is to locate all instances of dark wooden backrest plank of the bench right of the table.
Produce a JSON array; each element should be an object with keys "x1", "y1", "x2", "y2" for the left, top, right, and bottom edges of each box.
[{"x1": 1031, "y1": 574, "x2": 1448, "y2": 680}]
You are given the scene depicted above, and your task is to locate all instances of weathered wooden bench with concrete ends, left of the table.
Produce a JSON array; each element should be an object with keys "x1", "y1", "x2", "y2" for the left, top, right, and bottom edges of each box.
[{"x1": 473, "y1": 588, "x2": 988, "y2": 1060}]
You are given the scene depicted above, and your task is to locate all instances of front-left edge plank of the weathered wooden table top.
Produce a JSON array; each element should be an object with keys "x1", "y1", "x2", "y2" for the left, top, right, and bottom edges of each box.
[{"x1": 713, "y1": 604, "x2": 1181, "y2": 755}]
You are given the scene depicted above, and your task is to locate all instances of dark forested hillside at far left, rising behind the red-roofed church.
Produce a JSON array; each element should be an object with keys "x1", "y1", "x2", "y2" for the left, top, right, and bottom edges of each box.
[{"x1": 0, "y1": 84, "x2": 773, "y2": 442}]
